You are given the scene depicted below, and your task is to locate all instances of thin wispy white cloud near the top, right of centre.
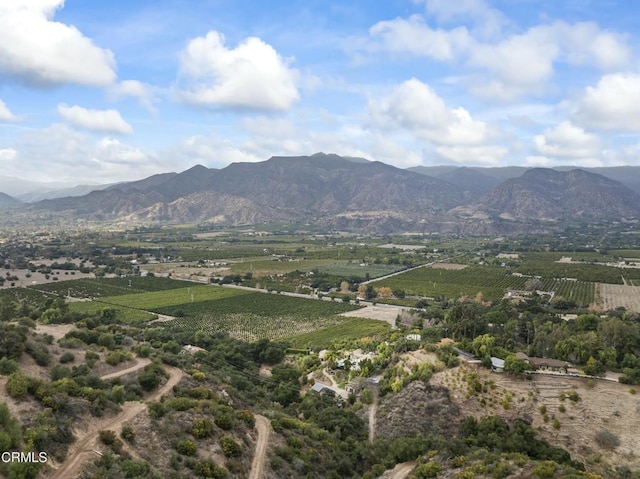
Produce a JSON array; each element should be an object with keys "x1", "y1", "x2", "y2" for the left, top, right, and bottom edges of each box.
[{"x1": 369, "y1": 15, "x2": 471, "y2": 60}]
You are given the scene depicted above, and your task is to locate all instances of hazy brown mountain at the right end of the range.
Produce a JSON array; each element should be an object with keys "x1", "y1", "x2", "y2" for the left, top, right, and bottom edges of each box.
[{"x1": 476, "y1": 168, "x2": 640, "y2": 221}]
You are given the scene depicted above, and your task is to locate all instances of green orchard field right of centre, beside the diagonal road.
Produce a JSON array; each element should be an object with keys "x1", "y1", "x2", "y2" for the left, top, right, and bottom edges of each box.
[{"x1": 373, "y1": 266, "x2": 528, "y2": 300}]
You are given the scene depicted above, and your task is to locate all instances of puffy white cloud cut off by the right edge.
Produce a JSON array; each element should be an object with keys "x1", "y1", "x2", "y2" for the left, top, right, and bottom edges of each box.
[{"x1": 572, "y1": 73, "x2": 640, "y2": 132}]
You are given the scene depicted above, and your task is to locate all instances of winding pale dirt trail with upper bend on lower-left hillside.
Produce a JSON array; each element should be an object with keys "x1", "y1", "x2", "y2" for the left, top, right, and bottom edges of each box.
[{"x1": 49, "y1": 361, "x2": 184, "y2": 479}]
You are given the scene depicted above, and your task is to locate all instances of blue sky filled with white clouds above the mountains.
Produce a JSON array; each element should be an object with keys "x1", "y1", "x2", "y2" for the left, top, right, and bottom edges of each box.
[{"x1": 0, "y1": 0, "x2": 640, "y2": 184}]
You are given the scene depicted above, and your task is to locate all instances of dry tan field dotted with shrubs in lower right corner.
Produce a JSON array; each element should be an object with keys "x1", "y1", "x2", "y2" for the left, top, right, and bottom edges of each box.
[{"x1": 431, "y1": 364, "x2": 640, "y2": 469}]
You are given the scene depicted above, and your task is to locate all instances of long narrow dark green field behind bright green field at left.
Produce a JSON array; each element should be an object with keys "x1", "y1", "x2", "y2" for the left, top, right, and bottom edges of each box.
[{"x1": 30, "y1": 276, "x2": 189, "y2": 298}]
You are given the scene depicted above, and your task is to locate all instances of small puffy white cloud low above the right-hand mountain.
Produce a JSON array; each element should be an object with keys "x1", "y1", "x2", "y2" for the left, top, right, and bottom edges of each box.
[{"x1": 533, "y1": 121, "x2": 602, "y2": 160}]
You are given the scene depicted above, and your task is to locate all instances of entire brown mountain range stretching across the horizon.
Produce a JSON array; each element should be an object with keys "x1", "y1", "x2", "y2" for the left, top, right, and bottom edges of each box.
[{"x1": 5, "y1": 153, "x2": 640, "y2": 233}]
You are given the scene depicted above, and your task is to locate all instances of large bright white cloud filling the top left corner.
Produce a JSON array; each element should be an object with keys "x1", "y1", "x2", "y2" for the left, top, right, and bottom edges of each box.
[{"x1": 0, "y1": 0, "x2": 116, "y2": 86}]
